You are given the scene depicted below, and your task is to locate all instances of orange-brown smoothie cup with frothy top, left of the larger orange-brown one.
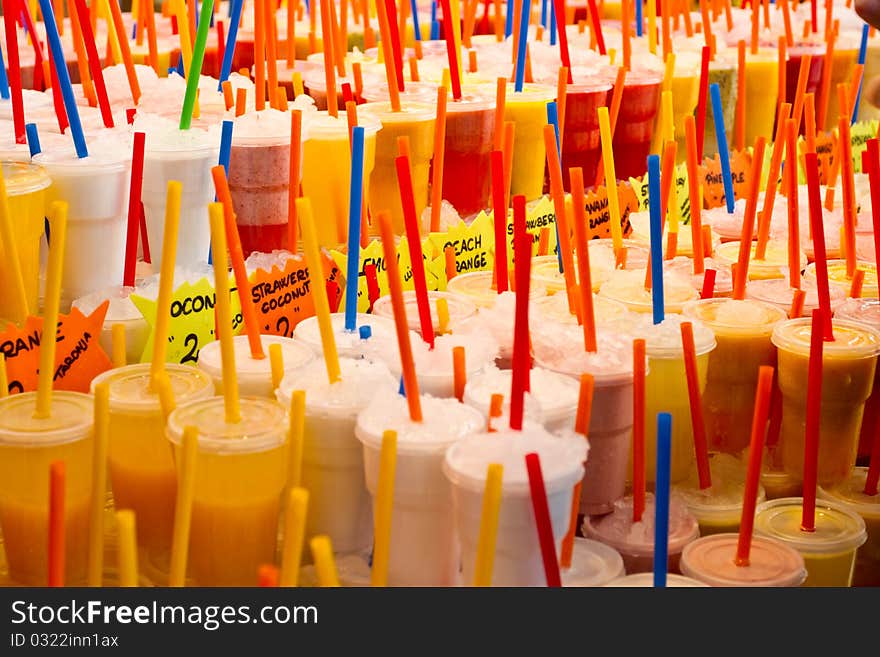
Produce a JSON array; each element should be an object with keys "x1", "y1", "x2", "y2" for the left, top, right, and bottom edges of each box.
[{"x1": 683, "y1": 299, "x2": 786, "y2": 454}]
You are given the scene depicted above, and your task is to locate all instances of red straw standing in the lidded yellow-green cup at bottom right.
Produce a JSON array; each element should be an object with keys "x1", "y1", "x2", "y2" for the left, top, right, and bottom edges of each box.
[{"x1": 801, "y1": 308, "x2": 824, "y2": 532}]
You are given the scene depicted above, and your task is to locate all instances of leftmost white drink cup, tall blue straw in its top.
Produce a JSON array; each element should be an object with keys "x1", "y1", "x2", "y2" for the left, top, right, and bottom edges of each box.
[{"x1": 31, "y1": 142, "x2": 131, "y2": 305}]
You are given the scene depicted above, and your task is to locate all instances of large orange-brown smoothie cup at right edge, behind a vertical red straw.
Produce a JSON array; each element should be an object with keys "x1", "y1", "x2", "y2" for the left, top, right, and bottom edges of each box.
[{"x1": 772, "y1": 319, "x2": 880, "y2": 486}]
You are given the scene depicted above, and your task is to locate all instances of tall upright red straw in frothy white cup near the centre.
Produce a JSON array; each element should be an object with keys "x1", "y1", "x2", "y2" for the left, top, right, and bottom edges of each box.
[{"x1": 510, "y1": 194, "x2": 532, "y2": 431}]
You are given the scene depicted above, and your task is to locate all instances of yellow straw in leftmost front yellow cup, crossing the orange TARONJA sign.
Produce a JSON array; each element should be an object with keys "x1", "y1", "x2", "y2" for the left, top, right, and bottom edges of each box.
[{"x1": 34, "y1": 201, "x2": 67, "y2": 419}]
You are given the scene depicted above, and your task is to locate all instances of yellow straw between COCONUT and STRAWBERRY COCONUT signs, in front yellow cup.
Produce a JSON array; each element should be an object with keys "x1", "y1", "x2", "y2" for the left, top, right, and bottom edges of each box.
[{"x1": 208, "y1": 203, "x2": 241, "y2": 424}]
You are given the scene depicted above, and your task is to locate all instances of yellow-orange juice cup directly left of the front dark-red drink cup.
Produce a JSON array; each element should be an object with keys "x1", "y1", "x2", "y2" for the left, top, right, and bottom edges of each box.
[{"x1": 359, "y1": 102, "x2": 437, "y2": 235}]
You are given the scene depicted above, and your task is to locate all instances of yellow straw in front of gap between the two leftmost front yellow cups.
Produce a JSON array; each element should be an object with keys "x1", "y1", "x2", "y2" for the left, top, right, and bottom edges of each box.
[{"x1": 86, "y1": 383, "x2": 110, "y2": 586}]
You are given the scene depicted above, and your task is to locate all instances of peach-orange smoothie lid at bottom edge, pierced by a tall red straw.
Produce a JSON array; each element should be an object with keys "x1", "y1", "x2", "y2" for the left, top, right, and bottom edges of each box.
[{"x1": 681, "y1": 534, "x2": 807, "y2": 587}]
